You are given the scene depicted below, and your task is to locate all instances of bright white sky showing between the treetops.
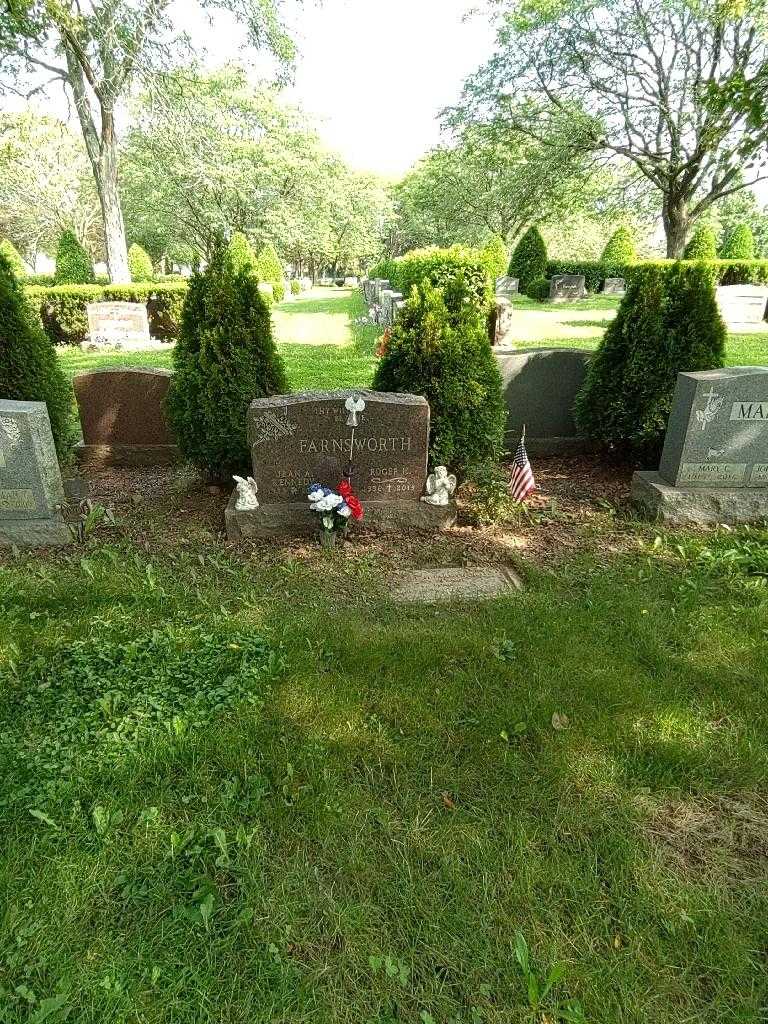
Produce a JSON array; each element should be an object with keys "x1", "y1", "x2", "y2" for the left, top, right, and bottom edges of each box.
[{"x1": 189, "y1": 0, "x2": 494, "y2": 176}]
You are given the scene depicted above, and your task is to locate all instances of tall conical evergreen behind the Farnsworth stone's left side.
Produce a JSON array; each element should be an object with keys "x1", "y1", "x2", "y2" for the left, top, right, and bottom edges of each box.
[{"x1": 167, "y1": 243, "x2": 288, "y2": 480}]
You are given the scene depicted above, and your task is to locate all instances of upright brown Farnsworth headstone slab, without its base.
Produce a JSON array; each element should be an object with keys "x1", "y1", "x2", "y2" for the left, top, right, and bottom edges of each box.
[{"x1": 248, "y1": 391, "x2": 429, "y2": 505}]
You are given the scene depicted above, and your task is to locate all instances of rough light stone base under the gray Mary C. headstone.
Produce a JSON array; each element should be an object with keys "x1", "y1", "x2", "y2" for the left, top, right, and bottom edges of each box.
[{"x1": 632, "y1": 470, "x2": 768, "y2": 526}]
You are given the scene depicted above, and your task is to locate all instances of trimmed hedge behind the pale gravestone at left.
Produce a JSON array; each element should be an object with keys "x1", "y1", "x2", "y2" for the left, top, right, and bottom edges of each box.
[{"x1": 25, "y1": 282, "x2": 187, "y2": 345}]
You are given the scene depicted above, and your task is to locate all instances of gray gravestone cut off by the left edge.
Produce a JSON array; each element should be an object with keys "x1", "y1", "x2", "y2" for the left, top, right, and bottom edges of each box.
[{"x1": 0, "y1": 400, "x2": 72, "y2": 547}]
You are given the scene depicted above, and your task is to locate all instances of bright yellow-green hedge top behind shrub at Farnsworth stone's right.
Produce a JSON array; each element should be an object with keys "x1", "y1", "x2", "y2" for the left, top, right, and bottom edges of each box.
[{"x1": 369, "y1": 246, "x2": 495, "y2": 313}]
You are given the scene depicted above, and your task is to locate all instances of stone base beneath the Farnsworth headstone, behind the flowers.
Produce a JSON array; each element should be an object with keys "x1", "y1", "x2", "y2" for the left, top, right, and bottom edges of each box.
[{"x1": 224, "y1": 490, "x2": 457, "y2": 541}]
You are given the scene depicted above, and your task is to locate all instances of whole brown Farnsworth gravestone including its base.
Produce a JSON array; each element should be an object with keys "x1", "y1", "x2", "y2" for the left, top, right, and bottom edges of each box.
[{"x1": 226, "y1": 391, "x2": 456, "y2": 540}]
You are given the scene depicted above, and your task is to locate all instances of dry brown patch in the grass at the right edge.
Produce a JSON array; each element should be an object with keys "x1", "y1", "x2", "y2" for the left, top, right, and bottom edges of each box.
[{"x1": 647, "y1": 794, "x2": 768, "y2": 883}]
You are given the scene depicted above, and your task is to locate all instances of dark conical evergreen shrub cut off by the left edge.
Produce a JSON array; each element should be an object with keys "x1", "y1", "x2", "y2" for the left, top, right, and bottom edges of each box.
[{"x1": 0, "y1": 254, "x2": 72, "y2": 455}]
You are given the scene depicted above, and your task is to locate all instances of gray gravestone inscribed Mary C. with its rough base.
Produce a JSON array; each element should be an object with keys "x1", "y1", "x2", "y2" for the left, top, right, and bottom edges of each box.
[{"x1": 633, "y1": 367, "x2": 768, "y2": 523}]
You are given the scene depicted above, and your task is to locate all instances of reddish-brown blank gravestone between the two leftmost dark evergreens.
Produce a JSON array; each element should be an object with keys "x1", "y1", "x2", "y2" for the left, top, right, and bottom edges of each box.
[{"x1": 73, "y1": 367, "x2": 178, "y2": 468}]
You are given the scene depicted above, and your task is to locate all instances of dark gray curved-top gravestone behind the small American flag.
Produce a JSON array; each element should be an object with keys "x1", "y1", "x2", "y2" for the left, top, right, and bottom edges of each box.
[{"x1": 497, "y1": 348, "x2": 594, "y2": 455}]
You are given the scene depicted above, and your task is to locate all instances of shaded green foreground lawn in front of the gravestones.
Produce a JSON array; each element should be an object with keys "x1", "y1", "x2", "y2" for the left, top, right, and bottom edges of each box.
[{"x1": 0, "y1": 516, "x2": 768, "y2": 1024}]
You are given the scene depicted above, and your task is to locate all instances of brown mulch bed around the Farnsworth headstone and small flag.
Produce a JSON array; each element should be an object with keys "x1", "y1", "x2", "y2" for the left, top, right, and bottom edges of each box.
[{"x1": 0, "y1": 457, "x2": 637, "y2": 569}]
